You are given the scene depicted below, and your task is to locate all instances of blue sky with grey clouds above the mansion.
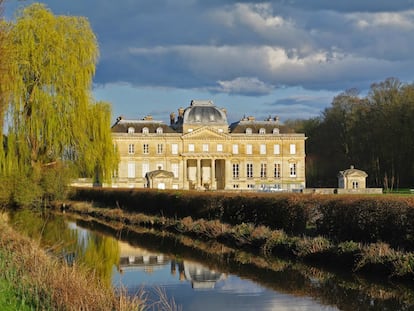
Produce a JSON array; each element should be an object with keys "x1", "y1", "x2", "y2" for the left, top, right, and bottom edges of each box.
[{"x1": 5, "y1": 0, "x2": 414, "y2": 123}]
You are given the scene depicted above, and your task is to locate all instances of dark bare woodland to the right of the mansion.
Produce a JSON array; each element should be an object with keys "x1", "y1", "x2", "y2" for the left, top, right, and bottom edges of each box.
[{"x1": 286, "y1": 78, "x2": 414, "y2": 189}]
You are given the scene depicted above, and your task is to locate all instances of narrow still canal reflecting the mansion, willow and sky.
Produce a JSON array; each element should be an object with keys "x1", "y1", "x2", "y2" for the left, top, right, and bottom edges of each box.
[{"x1": 4, "y1": 210, "x2": 414, "y2": 311}]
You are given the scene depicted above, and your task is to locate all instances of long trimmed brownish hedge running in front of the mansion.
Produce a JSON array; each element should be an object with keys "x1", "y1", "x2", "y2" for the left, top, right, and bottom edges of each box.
[{"x1": 71, "y1": 188, "x2": 414, "y2": 250}]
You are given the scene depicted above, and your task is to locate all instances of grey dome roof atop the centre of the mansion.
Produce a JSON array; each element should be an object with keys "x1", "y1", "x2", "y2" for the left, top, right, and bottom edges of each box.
[{"x1": 183, "y1": 100, "x2": 228, "y2": 125}]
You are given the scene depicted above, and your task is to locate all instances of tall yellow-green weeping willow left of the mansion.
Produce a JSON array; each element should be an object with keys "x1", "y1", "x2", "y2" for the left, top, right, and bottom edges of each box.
[{"x1": 4, "y1": 3, "x2": 116, "y2": 184}]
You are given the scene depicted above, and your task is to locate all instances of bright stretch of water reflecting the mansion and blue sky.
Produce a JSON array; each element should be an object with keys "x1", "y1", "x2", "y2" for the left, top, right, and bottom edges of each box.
[{"x1": 113, "y1": 241, "x2": 338, "y2": 311}]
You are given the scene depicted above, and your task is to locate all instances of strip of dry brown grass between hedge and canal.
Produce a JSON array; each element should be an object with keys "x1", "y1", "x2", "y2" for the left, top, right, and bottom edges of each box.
[{"x1": 55, "y1": 202, "x2": 414, "y2": 280}]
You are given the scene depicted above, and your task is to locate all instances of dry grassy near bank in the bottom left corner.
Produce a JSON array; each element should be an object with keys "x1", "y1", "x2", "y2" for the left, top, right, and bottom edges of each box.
[{"x1": 0, "y1": 213, "x2": 144, "y2": 311}]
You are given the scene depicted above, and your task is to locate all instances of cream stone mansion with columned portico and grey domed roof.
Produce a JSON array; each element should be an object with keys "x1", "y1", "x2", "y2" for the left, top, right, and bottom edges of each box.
[{"x1": 112, "y1": 101, "x2": 306, "y2": 191}]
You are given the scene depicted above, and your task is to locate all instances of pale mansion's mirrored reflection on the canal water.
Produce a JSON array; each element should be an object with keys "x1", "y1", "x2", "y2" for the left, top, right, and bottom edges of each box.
[{"x1": 118, "y1": 241, "x2": 227, "y2": 289}]
